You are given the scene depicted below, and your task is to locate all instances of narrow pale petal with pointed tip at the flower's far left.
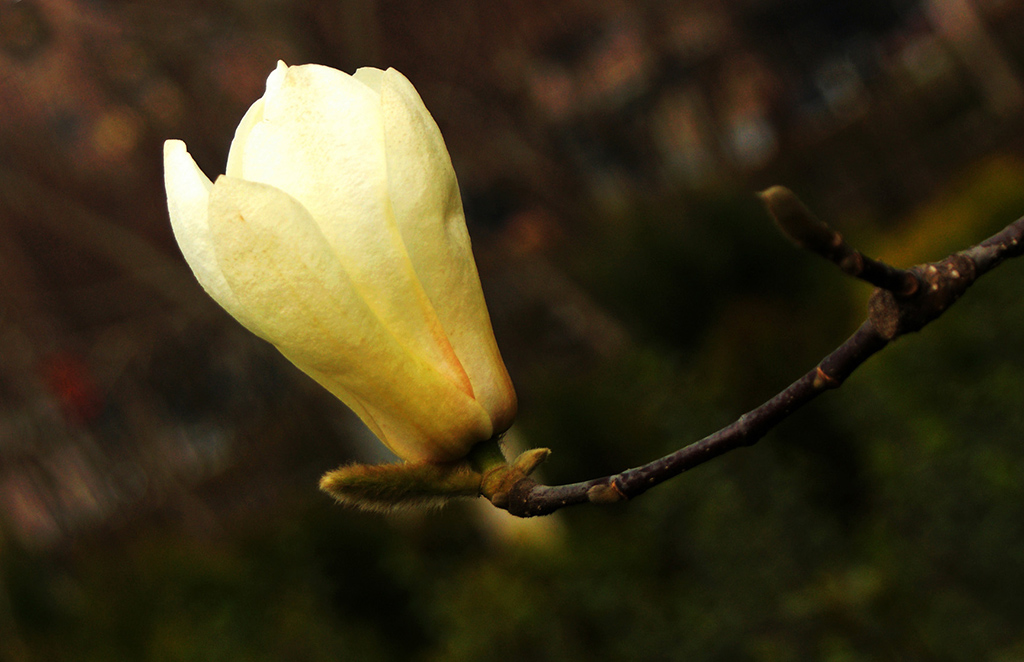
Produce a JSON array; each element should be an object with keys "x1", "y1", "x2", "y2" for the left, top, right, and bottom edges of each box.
[{"x1": 164, "y1": 140, "x2": 260, "y2": 335}]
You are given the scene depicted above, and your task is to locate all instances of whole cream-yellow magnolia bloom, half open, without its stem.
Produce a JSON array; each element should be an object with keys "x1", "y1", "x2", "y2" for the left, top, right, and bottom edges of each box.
[{"x1": 164, "y1": 63, "x2": 516, "y2": 462}]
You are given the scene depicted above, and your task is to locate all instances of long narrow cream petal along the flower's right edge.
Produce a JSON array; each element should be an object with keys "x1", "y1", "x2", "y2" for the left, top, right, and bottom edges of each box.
[{"x1": 380, "y1": 69, "x2": 516, "y2": 431}]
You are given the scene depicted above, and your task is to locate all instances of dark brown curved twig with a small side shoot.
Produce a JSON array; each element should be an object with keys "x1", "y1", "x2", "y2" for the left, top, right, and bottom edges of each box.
[{"x1": 501, "y1": 188, "x2": 1024, "y2": 518}]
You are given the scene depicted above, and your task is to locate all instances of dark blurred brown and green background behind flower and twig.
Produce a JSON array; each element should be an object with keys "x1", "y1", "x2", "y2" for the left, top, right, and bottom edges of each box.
[{"x1": 0, "y1": 0, "x2": 1024, "y2": 662}]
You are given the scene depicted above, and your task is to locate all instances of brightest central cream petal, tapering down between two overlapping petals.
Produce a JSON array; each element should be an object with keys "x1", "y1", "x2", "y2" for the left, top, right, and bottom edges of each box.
[{"x1": 237, "y1": 65, "x2": 472, "y2": 403}]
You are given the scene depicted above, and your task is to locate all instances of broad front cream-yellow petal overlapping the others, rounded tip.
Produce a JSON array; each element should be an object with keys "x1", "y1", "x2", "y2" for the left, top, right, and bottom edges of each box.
[{"x1": 210, "y1": 177, "x2": 493, "y2": 461}]
